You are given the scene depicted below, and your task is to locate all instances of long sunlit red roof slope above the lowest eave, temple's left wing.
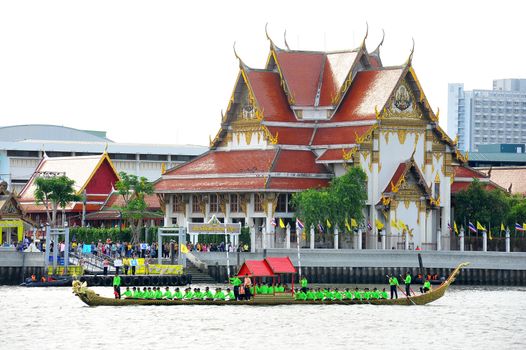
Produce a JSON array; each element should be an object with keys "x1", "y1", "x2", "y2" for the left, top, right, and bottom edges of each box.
[{"x1": 165, "y1": 150, "x2": 276, "y2": 175}]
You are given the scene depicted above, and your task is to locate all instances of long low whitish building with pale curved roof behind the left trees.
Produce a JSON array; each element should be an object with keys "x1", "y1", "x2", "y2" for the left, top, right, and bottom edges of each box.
[{"x1": 0, "y1": 125, "x2": 206, "y2": 192}]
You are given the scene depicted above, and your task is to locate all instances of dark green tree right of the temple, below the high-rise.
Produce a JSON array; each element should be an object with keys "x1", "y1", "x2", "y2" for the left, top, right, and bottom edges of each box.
[{"x1": 455, "y1": 179, "x2": 510, "y2": 226}]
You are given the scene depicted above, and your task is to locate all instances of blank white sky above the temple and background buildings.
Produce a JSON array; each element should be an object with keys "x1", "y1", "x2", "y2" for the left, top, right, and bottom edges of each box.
[{"x1": 0, "y1": 0, "x2": 526, "y2": 145}]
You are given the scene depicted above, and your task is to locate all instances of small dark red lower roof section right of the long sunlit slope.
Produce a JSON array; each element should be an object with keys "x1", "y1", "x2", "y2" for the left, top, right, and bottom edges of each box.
[{"x1": 272, "y1": 150, "x2": 327, "y2": 174}]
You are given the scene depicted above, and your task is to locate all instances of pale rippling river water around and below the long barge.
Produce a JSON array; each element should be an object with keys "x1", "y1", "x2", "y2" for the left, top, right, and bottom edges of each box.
[{"x1": 0, "y1": 286, "x2": 526, "y2": 350}]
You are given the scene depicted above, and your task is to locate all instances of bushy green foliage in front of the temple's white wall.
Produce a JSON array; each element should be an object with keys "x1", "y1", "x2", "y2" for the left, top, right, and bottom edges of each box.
[{"x1": 292, "y1": 167, "x2": 367, "y2": 230}]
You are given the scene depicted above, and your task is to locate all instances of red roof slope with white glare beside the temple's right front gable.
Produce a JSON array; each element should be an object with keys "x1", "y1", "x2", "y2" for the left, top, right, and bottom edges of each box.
[{"x1": 331, "y1": 68, "x2": 404, "y2": 122}]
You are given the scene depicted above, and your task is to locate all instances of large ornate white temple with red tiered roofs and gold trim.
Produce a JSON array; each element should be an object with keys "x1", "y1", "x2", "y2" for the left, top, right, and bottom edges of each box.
[{"x1": 155, "y1": 29, "x2": 476, "y2": 249}]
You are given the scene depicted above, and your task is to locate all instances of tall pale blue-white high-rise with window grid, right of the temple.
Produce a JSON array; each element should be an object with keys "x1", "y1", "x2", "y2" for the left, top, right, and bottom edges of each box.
[{"x1": 447, "y1": 79, "x2": 526, "y2": 152}]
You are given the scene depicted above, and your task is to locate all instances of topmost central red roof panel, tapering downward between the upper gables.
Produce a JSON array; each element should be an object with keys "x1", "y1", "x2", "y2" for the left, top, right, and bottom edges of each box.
[{"x1": 276, "y1": 51, "x2": 325, "y2": 106}]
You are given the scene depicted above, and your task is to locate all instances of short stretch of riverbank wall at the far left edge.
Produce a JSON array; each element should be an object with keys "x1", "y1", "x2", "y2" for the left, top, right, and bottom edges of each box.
[{"x1": 0, "y1": 251, "x2": 44, "y2": 285}]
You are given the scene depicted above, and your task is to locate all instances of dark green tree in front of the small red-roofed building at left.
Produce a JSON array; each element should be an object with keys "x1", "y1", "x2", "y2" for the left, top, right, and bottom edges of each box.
[{"x1": 35, "y1": 175, "x2": 80, "y2": 227}]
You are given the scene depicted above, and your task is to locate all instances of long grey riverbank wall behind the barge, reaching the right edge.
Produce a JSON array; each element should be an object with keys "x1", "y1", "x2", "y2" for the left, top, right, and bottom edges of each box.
[{"x1": 196, "y1": 249, "x2": 526, "y2": 286}]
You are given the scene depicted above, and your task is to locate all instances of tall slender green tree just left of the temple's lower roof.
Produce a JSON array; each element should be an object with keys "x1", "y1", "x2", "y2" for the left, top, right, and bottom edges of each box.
[{"x1": 115, "y1": 172, "x2": 157, "y2": 244}]
